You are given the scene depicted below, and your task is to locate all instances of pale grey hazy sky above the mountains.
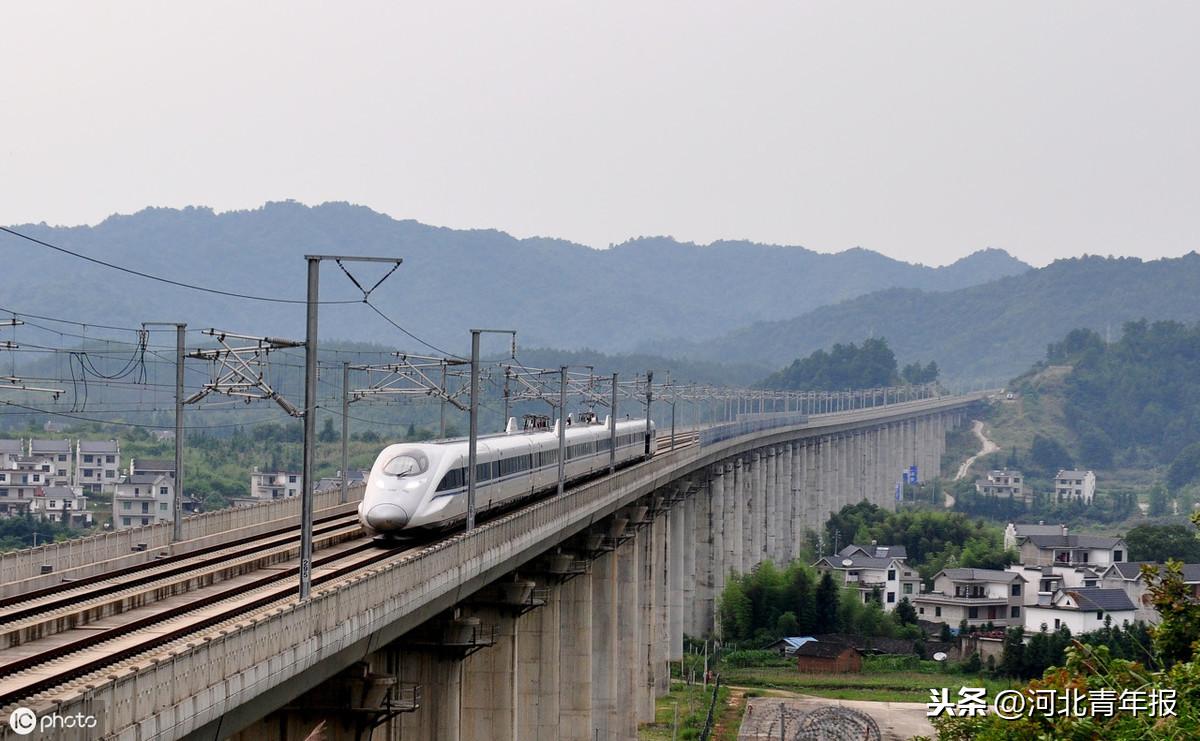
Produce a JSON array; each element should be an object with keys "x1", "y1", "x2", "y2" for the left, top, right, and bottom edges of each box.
[{"x1": 0, "y1": 0, "x2": 1200, "y2": 264}]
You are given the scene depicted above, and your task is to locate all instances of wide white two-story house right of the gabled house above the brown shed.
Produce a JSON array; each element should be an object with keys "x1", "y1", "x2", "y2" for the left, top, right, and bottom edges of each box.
[{"x1": 912, "y1": 568, "x2": 1025, "y2": 627}]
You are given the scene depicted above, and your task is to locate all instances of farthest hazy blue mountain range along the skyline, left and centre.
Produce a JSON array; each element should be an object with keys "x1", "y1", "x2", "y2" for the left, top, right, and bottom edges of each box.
[{"x1": 0, "y1": 201, "x2": 1028, "y2": 352}]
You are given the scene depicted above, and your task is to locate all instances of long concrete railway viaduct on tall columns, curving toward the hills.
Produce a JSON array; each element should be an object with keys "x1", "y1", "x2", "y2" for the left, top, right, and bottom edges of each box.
[{"x1": 0, "y1": 394, "x2": 983, "y2": 741}]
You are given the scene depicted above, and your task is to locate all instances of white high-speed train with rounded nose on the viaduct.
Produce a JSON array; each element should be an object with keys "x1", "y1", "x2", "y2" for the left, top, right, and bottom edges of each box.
[{"x1": 359, "y1": 415, "x2": 656, "y2": 536}]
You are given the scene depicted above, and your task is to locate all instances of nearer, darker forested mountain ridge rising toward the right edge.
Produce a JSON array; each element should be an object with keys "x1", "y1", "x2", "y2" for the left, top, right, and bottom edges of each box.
[{"x1": 655, "y1": 253, "x2": 1200, "y2": 384}]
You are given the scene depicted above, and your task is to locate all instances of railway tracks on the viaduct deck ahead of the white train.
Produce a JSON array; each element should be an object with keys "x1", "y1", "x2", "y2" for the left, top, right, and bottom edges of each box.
[{"x1": 0, "y1": 432, "x2": 700, "y2": 711}]
